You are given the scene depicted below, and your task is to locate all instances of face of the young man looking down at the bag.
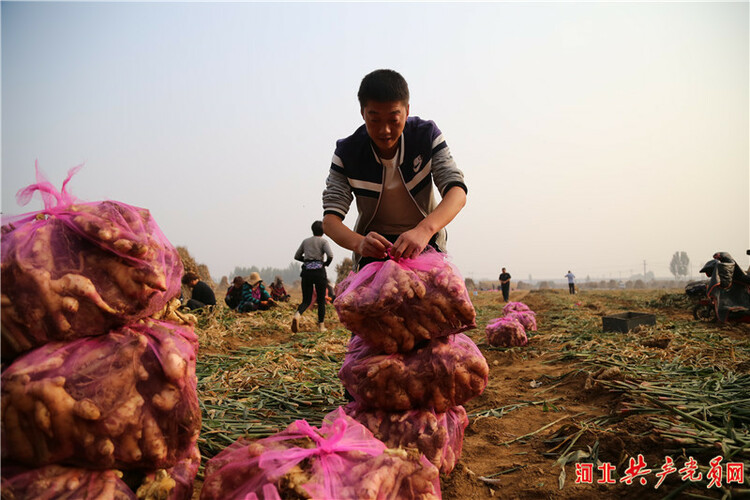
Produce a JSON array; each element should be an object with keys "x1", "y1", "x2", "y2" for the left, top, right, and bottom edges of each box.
[{"x1": 362, "y1": 101, "x2": 409, "y2": 158}]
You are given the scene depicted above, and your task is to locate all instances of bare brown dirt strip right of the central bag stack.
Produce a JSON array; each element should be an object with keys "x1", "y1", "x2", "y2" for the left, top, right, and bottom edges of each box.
[{"x1": 442, "y1": 292, "x2": 647, "y2": 499}]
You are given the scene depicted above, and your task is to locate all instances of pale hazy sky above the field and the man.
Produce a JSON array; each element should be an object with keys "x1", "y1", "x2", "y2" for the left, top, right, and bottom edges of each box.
[{"x1": 0, "y1": 2, "x2": 750, "y2": 280}]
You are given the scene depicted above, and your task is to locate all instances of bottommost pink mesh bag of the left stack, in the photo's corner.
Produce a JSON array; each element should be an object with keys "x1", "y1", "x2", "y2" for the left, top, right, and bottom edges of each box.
[{"x1": 2, "y1": 465, "x2": 136, "y2": 500}]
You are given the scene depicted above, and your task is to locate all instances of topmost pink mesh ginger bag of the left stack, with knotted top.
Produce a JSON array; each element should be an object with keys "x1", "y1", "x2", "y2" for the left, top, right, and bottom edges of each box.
[{"x1": 0, "y1": 167, "x2": 183, "y2": 358}]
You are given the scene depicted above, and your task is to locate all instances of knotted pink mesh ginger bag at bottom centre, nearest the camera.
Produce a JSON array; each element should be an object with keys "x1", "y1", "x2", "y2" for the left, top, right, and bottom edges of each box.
[{"x1": 201, "y1": 408, "x2": 441, "y2": 500}]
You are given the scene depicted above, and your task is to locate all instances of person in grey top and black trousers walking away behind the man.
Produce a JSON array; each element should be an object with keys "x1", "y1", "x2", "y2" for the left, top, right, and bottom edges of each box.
[{"x1": 292, "y1": 220, "x2": 333, "y2": 333}]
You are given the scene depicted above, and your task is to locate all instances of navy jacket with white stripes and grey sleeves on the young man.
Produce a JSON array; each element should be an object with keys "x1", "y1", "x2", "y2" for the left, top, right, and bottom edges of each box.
[{"x1": 323, "y1": 116, "x2": 467, "y2": 251}]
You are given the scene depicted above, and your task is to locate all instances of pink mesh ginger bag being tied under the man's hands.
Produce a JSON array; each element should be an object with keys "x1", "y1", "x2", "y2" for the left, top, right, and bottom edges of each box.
[{"x1": 333, "y1": 249, "x2": 476, "y2": 354}]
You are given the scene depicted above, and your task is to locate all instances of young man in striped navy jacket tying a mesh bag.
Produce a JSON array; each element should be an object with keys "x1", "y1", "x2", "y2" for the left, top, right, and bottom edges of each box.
[{"x1": 323, "y1": 69, "x2": 467, "y2": 269}]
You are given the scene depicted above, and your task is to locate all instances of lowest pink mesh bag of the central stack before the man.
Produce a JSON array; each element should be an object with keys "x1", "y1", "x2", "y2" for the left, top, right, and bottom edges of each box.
[{"x1": 344, "y1": 403, "x2": 469, "y2": 474}]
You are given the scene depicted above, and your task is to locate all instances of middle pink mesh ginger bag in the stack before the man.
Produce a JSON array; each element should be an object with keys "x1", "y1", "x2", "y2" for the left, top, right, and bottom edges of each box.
[{"x1": 339, "y1": 333, "x2": 489, "y2": 413}]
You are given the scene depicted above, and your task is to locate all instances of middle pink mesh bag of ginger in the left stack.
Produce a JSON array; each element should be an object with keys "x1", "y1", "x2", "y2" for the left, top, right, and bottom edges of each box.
[{"x1": 1, "y1": 321, "x2": 201, "y2": 469}]
